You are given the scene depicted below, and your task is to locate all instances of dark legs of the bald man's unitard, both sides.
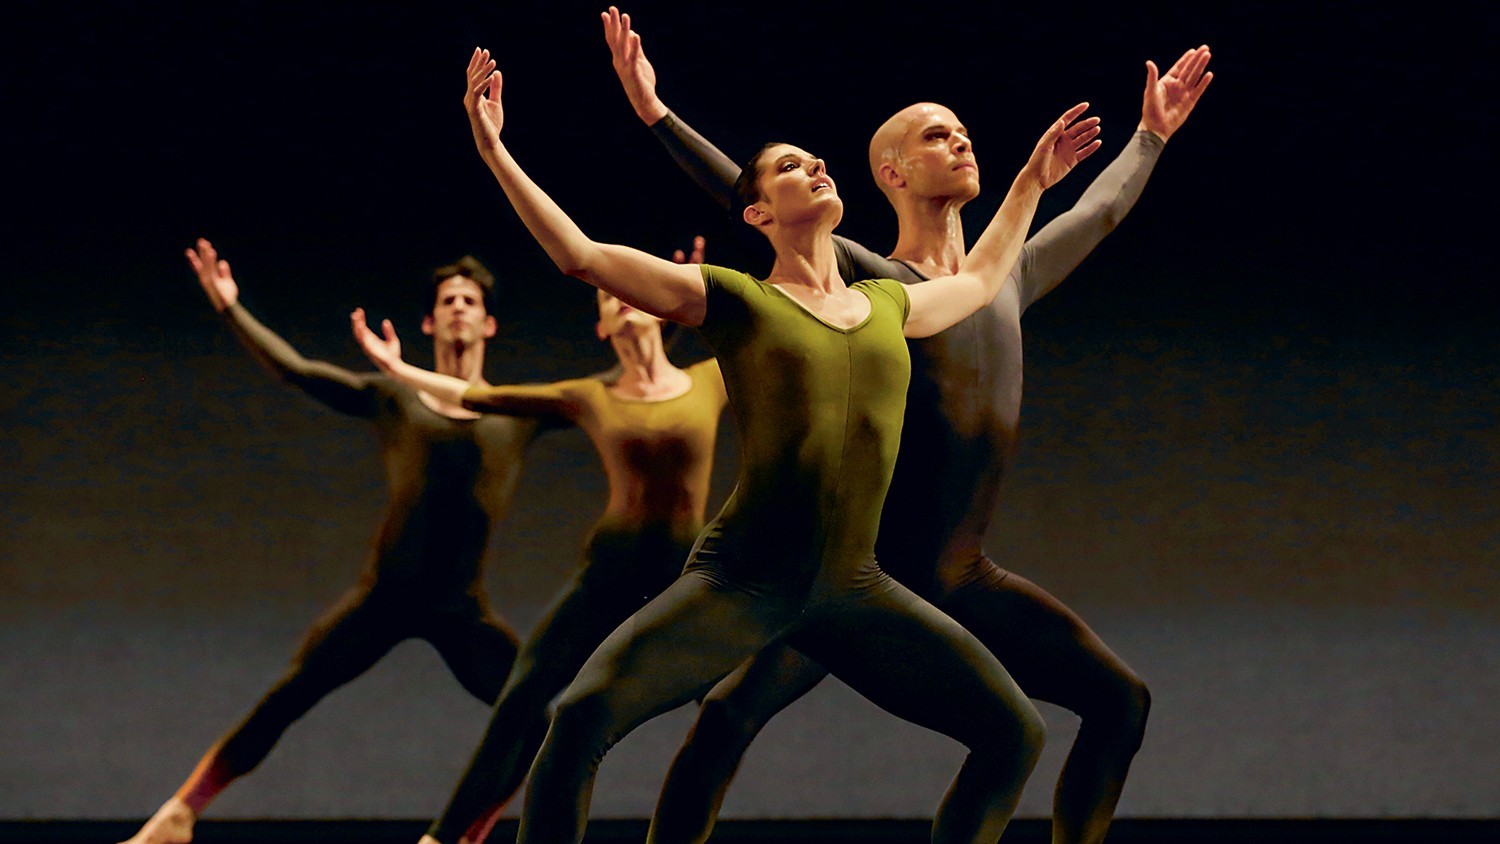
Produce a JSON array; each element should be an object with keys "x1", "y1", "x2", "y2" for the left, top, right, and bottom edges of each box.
[{"x1": 648, "y1": 558, "x2": 1151, "y2": 844}]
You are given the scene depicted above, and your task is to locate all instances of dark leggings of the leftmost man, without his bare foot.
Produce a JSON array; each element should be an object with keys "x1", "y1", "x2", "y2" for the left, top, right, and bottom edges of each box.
[{"x1": 177, "y1": 585, "x2": 518, "y2": 811}]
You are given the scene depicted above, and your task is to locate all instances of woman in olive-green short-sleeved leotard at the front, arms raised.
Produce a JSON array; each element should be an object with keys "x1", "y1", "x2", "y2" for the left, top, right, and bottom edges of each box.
[{"x1": 429, "y1": 49, "x2": 1098, "y2": 844}]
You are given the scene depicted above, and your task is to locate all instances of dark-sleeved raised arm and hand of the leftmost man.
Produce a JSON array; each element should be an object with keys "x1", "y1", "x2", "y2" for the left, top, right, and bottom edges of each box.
[{"x1": 186, "y1": 237, "x2": 375, "y2": 417}]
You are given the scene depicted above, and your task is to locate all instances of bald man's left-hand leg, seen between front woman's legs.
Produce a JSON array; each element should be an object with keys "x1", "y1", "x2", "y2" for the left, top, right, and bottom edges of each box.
[{"x1": 647, "y1": 643, "x2": 828, "y2": 844}]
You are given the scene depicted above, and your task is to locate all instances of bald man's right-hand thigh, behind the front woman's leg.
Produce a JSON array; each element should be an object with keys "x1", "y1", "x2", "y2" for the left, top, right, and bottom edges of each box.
[{"x1": 939, "y1": 561, "x2": 1136, "y2": 714}]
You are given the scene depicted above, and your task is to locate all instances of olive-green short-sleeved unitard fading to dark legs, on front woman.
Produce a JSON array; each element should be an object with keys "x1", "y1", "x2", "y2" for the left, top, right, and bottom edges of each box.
[{"x1": 521, "y1": 267, "x2": 1041, "y2": 844}]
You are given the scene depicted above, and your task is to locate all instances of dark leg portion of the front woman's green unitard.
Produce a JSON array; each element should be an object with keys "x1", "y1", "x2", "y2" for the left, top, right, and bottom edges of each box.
[{"x1": 519, "y1": 568, "x2": 1046, "y2": 844}]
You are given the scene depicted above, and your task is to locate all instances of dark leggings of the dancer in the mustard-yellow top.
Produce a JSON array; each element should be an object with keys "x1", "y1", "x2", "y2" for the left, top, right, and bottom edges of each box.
[{"x1": 428, "y1": 531, "x2": 693, "y2": 843}]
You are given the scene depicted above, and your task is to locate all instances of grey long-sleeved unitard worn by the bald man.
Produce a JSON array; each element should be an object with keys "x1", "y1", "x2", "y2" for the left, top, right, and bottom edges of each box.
[{"x1": 651, "y1": 114, "x2": 1163, "y2": 844}]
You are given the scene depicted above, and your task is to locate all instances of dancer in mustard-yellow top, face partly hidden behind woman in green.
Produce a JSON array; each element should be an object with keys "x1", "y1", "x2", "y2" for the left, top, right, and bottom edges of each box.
[{"x1": 354, "y1": 263, "x2": 726, "y2": 840}]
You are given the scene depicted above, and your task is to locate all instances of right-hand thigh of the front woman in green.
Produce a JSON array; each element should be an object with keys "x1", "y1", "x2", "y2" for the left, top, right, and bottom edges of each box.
[{"x1": 788, "y1": 580, "x2": 1037, "y2": 742}]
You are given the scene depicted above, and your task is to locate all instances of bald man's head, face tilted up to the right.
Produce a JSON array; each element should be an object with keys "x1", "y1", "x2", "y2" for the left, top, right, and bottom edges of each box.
[{"x1": 878, "y1": 102, "x2": 980, "y2": 201}]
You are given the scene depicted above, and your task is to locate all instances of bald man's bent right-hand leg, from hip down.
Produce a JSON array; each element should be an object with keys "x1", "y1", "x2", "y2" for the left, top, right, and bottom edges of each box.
[{"x1": 939, "y1": 561, "x2": 1151, "y2": 844}]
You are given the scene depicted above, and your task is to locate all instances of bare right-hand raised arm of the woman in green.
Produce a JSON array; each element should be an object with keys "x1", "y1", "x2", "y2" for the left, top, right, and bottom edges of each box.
[{"x1": 906, "y1": 102, "x2": 1100, "y2": 337}]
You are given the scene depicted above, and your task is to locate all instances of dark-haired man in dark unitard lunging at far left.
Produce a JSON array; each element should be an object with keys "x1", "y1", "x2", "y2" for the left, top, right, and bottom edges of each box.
[{"x1": 121, "y1": 240, "x2": 543, "y2": 844}]
